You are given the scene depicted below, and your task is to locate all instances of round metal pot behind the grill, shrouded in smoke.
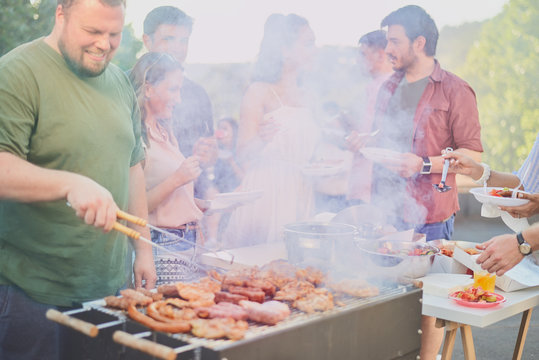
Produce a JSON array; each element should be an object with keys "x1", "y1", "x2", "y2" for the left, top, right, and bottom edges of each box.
[{"x1": 283, "y1": 222, "x2": 358, "y2": 268}]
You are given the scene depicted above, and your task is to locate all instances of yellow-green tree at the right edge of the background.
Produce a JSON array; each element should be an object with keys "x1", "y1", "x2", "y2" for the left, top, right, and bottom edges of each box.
[{"x1": 462, "y1": 0, "x2": 539, "y2": 171}]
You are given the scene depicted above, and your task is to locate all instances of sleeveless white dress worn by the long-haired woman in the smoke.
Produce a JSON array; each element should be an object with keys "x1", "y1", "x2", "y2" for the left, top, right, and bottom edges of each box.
[{"x1": 223, "y1": 103, "x2": 319, "y2": 249}]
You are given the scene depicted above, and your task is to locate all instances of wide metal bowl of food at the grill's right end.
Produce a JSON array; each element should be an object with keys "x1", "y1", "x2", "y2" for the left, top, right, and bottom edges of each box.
[{"x1": 357, "y1": 240, "x2": 440, "y2": 278}]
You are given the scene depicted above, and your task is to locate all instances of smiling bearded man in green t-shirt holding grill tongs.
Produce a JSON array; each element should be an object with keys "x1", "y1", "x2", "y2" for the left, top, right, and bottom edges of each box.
[{"x1": 0, "y1": 0, "x2": 156, "y2": 360}]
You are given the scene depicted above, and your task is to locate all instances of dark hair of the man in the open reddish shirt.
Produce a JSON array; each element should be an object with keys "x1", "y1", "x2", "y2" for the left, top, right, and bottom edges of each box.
[{"x1": 381, "y1": 5, "x2": 438, "y2": 56}]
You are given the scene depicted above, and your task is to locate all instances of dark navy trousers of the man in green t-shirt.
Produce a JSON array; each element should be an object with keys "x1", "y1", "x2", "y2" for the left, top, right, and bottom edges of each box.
[{"x1": 0, "y1": 285, "x2": 73, "y2": 360}]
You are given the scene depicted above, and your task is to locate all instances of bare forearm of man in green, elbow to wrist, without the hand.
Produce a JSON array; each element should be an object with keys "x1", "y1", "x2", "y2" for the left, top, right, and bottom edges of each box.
[{"x1": 0, "y1": 152, "x2": 80, "y2": 202}]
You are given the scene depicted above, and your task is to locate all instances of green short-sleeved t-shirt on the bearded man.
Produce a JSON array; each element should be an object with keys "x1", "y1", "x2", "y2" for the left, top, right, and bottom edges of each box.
[{"x1": 0, "y1": 39, "x2": 144, "y2": 306}]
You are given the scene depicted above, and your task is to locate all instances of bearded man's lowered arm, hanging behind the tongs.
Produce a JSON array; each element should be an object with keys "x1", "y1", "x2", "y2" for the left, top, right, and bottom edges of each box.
[{"x1": 128, "y1": 163, "x2": 157, "y2": 289}]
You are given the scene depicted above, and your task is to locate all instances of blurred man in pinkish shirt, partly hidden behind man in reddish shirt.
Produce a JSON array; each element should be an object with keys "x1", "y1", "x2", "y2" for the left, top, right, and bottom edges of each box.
[{"x1": 346, "y1": 30, "x2": 393, "y2": 205}]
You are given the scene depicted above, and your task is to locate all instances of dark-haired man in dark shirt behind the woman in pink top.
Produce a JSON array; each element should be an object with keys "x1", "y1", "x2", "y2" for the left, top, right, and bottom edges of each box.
[{"x1": 143, "y1": 6, "x2": 217, "y2": 198}]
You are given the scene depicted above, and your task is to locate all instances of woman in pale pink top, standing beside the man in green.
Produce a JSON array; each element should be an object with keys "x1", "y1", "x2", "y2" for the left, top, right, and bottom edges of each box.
[{"x1": 130, "y1": 53, "x2": 203, "y2": 285}]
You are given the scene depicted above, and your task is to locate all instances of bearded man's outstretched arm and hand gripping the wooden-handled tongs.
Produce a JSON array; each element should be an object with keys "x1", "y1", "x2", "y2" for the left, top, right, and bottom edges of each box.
[{"x1": 0, "y1": 152, "x2": 118, "y2": 231}]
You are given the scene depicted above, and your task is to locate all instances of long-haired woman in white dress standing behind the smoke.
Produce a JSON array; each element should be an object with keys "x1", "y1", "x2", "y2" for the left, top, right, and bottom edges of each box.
[{"x1": 223, "y1": 14, "x2": 318, "y2": 248}]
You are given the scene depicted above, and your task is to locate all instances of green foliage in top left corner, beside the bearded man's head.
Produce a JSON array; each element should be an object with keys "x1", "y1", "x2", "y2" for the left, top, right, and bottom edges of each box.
[{"x1": 0, "y1": 0, "x2": 56, "y2": 56}]
